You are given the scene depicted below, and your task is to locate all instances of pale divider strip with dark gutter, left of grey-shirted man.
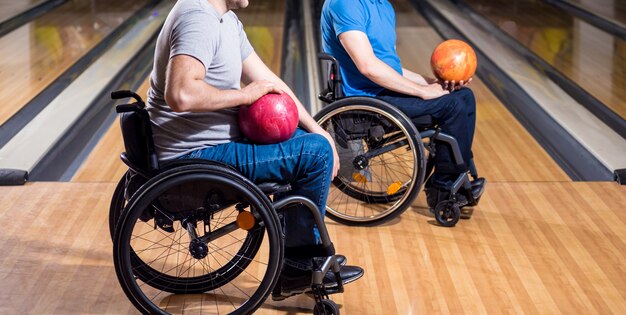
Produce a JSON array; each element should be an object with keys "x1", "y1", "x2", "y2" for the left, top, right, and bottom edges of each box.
[{"x1": 0, "y1": 1, "x2": 174, "y2": 185}]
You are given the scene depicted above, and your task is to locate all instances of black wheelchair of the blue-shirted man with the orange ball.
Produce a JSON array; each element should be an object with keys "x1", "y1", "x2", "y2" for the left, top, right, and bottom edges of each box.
[{"x1": 314, "y1": 53, "x2": 479, "y2": 227}]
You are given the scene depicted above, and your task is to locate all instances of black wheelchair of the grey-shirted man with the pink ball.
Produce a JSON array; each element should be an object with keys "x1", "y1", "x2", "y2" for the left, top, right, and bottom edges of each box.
[{"x1": 109, "y1": 91, "x2": 343, "y2": 314}]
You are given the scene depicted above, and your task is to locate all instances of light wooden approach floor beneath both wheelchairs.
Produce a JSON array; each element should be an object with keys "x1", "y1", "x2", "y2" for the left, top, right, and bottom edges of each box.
[{"x1": 0, "y1": 182, "x2": 626, "y2": 314}]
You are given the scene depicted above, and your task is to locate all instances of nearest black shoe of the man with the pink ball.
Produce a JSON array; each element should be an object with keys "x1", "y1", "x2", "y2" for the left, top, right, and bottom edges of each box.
[{"x1": 272, "y1": 265, "x2": 364, "y2": 301}]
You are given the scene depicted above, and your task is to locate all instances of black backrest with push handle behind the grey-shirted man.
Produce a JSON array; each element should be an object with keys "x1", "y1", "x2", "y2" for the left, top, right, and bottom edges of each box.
[{"x1": 111, "y1": 91, "x2": 159, "y2": 177}]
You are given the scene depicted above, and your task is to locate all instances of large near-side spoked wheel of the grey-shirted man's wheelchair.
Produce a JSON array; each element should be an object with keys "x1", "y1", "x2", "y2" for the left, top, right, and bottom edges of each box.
[{"x1": 113, "y1": 165, "x2": 284, "y2": 314}]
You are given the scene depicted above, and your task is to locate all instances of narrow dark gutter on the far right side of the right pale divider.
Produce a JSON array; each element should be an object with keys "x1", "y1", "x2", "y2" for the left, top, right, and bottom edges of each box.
[{"x1": 457, "y1": 0, "x2": 626, "y2": 138}]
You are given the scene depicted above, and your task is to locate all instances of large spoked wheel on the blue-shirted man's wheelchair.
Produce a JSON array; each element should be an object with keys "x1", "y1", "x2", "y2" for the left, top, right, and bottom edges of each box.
[{"x1": 315, "y1": 97, "x2": 426, "y2": 226}]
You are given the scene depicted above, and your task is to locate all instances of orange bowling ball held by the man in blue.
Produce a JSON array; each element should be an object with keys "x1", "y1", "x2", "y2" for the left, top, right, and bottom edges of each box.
[{"x1": 430, "y1": 39, "x2": 477, "y2": 82}]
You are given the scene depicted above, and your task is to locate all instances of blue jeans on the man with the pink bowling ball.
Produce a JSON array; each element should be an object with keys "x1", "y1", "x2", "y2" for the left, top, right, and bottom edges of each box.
[{"x1": 181, "y1": 129, "x2": 333, "y2": 254}]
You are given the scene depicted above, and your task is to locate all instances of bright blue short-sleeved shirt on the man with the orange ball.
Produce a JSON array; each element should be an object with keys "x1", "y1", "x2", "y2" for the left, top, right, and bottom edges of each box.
[{"x1": 320, "y1": 0, "x2": 402, "y2": 96}]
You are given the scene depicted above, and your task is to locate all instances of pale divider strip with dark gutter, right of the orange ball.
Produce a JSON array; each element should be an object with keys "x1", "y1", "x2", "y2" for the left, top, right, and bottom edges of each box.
[{"x1": 411, "y1": 0, "x2": 626, "y2": 181}]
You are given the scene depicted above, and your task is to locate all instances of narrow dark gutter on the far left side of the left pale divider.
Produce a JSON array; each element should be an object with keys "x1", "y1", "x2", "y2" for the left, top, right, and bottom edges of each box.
[{"x1": 0, "y1": 0, "x2": 160, "y2": 148}]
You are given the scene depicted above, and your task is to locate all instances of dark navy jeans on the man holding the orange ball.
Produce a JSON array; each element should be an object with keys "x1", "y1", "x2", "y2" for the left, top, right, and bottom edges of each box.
[{"x1": 377, "y1": 88, "x2": 476, "y2": 187}]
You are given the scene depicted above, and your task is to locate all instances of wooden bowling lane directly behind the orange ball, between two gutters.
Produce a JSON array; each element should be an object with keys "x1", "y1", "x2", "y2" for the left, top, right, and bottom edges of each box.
[{"x1": 394, "y1": 1, "x2": 570, "y2": 182}]
